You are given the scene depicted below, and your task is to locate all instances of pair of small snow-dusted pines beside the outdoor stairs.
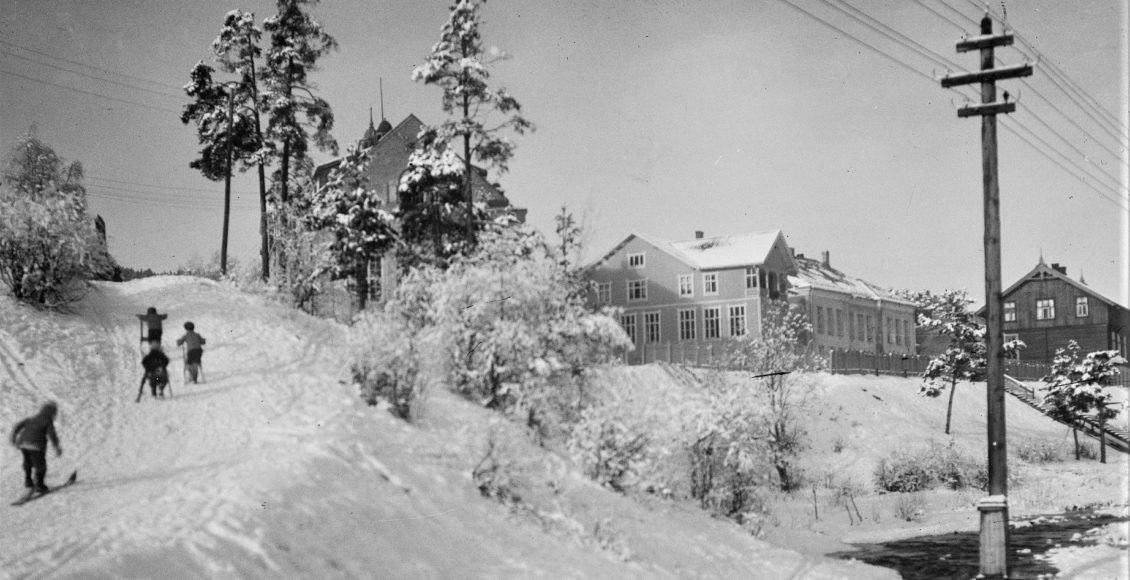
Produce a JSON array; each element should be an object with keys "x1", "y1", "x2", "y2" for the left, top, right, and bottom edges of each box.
[{"x1": 1044, "y1": 340, "x2": 1127, "y2": 464}]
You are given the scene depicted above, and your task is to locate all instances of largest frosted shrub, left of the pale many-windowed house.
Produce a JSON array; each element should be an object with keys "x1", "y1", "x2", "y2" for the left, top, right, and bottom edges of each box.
[{"x1": 426, "y1": 221, "x2": 629, "y2": 426}]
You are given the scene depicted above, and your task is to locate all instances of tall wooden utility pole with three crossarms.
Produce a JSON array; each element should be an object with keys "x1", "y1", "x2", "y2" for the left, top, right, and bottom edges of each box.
[{"x1": 941, "y1": 14, "x2": 1032, "y2": 579}]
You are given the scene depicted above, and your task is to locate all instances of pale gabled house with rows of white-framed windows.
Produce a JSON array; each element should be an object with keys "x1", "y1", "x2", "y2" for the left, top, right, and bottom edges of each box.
[{"x1": 586, "y1": 230, "x2": 797, "y2": 357}]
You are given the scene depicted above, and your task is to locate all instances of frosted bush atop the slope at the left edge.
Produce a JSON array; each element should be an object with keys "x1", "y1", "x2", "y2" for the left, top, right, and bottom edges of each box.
[{"x1": 0, "y1": 132, "x2": 109, "y2": 308}]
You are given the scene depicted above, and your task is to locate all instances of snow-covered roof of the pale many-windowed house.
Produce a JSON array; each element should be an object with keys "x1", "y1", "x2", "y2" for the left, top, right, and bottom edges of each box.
[{"x1": 586, "y1": 230, "x2": 791, "y2": 270}]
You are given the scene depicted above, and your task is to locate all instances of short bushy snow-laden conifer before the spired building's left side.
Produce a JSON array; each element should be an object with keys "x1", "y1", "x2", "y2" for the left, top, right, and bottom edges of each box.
[{"x1": 310, "y1": 145, "x2": 397, "y2": 310}]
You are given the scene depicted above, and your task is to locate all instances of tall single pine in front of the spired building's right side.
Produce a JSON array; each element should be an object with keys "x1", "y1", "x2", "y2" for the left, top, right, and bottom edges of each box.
[{"x1": 412, "y1": 0, "x2": 533, "y2": 243}]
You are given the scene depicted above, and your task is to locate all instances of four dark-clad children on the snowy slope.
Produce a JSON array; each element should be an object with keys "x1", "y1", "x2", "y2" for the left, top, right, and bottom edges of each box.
[{"x1": 9, "y1": 306, "x2": 205, "y2": 493}]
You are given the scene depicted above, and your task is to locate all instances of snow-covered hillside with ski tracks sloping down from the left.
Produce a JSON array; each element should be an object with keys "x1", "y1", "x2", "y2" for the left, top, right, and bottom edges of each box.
[{"x1": 0, "y1": 277, "x2": 894, "y2": 578}]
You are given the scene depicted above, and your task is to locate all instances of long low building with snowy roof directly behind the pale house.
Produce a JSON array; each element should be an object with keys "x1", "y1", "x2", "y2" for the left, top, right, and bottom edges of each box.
[{"x1": 789, "y1": 251, "x2": 918, "y2": 355}]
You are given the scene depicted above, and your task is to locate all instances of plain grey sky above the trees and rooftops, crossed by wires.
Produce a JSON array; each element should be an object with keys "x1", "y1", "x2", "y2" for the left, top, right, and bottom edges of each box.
[{"x1": 0, "y1": 0, "x2": 1127, "y2": 301}]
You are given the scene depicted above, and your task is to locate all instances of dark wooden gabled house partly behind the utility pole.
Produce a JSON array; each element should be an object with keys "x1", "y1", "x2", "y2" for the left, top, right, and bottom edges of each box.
[{"x1": 977, "y1": 257, "x2": 1130, "y2": 363}]
